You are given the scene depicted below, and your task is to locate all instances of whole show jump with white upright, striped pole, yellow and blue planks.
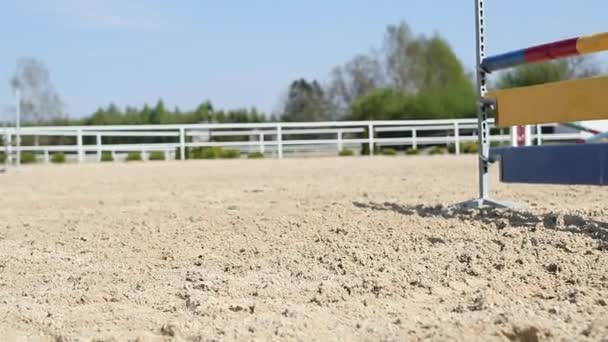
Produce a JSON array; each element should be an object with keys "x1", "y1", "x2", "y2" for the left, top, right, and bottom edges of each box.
[{"x1": 461, "y1": 0, "x2": 608, "y2": 208}]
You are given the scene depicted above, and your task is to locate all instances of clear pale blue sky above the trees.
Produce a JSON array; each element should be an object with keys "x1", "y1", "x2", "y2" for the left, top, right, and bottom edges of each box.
[{"x1": 0, "y1": 0, "x2": 608, "y2": 117}]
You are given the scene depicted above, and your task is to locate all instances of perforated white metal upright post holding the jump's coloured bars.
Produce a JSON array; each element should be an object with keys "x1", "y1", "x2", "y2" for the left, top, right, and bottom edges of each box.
[{"x1": 475, "y1": 0, "x2": 490, "y2": 200}]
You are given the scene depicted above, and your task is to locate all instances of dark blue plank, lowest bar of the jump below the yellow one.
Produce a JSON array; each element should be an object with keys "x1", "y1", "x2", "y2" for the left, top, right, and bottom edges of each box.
[{"x1": 490, "y1": 144, "x2": 608, "y2": 185}]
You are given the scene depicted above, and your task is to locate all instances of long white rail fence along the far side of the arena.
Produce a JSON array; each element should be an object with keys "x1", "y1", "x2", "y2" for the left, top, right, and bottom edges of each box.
[{"x1": 4, "y1": 119, "x2": 584, "y2": 162}]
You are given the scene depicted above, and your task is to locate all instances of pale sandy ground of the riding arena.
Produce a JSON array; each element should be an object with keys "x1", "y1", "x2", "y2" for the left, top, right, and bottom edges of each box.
[{"x1": 0, "y1": 156, "x2": 608, "y2": 341}]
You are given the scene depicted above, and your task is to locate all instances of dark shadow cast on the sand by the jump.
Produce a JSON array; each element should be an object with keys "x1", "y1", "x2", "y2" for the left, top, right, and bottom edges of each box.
[{"x1": 353, "y1": 202, "x2": 608, "y2": 246}]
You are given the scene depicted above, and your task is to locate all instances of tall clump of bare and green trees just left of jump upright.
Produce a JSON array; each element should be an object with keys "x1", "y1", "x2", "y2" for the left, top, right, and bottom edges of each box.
[{"x1": 328, "y1": 22, "x2": 476, "y2": 120}]
